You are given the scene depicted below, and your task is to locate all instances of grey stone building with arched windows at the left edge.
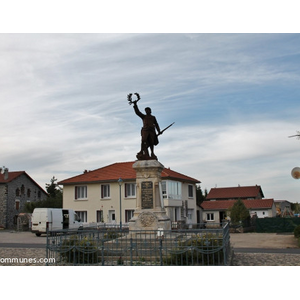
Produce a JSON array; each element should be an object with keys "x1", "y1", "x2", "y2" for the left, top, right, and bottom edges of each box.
[{"x1": 0, "y1": 171, "x2": 48, "y2": 229}]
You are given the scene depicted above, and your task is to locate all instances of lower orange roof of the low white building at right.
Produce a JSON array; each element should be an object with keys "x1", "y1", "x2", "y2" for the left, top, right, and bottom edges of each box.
[{"x1": 201, "y1": 199, "x2": 274, "y2": 210}]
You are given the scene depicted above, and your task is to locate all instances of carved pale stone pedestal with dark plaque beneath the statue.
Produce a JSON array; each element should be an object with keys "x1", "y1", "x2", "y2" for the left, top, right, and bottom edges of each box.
[{"x1": 129, "y1": 160, "x2": 171, "y2": 230}]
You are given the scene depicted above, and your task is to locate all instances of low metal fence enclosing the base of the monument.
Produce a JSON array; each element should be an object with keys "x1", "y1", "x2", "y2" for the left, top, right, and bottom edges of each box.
[{"x1": 46, "y1": 223, "x2": 231, "y2": 266}]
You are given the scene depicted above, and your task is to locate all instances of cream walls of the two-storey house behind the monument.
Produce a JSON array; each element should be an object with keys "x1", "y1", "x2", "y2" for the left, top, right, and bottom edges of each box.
[{"x1": 63, "y1": 181, "x2": 197, "y2": 224}]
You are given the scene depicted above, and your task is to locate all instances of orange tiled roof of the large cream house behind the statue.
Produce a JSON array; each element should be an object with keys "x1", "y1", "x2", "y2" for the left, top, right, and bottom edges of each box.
[{"x1": 58, "y1": 161, "x2": 200, "y2": 185}]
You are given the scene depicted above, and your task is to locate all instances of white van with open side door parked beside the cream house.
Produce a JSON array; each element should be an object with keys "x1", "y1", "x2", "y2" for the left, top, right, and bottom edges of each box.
[{"x1": 31, "y1": 208, "x2": 82, "y2": 236}]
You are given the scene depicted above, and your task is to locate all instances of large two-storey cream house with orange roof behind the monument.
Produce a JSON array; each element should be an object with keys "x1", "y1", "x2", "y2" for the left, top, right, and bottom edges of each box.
[{"x1": 58, "y1": 162, "x2": 200, "y2": 224}]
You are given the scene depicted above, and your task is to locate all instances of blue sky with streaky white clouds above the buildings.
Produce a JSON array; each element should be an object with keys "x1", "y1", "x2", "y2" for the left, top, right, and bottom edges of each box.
[{"x1": 0, "y1": 33, "x2": 300, "y2": 202}]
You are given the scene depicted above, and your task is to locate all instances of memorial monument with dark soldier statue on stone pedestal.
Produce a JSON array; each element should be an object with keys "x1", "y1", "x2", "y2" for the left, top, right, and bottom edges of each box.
[{"x1": 127, "y1": 93, "x2": 174, "y2": 230}]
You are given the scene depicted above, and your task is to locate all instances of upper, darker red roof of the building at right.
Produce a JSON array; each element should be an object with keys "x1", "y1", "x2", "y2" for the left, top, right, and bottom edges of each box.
[{"x1": 206, "y1": 185, "x2": 264, "y2": 200}]
